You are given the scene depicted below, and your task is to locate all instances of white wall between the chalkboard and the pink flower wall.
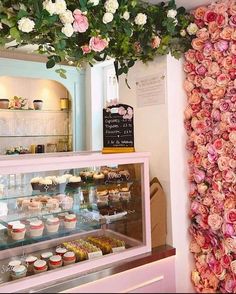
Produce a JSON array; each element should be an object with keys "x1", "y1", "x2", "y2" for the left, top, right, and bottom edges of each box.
[{"x1": 119, "y1": 56, "x2": 193, "y2": 293}]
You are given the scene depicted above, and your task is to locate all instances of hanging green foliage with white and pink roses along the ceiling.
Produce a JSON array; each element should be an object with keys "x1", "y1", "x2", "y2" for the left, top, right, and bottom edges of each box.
[{"x1": 0, "y1": 0, "x2": 195, "y2": 77}]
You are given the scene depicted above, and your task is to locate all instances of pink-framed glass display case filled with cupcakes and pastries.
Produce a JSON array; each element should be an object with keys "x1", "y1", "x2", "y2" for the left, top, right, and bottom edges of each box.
[{"x1": 0, "y1": 152, "x2": 151, "y2": 293}]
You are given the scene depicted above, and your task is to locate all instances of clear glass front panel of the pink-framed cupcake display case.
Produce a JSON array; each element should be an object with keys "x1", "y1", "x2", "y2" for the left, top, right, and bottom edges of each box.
[{"x1": 0, "y1": 164, "x2": 145, "y2": 282}]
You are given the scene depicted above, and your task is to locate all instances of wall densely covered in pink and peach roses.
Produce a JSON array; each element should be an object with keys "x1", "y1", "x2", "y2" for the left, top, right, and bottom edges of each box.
[{"x1": 184, "y1": 1, "x2": 236, "y2": 293}]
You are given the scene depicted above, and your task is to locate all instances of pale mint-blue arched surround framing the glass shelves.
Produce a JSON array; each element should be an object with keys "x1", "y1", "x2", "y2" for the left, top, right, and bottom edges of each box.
[{"x1": 0, "y1": 58, "x2": 86, "y2": 151}]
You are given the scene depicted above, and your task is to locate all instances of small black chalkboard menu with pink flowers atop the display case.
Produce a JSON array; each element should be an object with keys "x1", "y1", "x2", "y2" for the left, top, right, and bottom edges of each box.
[{"x1": 103, "y1": 104, "x2": 134, "y2": 153}]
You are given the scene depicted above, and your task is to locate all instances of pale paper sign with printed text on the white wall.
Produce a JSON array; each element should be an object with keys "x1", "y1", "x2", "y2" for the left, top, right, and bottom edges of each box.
[{"x1": 135, "y1": 73, "x2": 165, "y2": 107}]
